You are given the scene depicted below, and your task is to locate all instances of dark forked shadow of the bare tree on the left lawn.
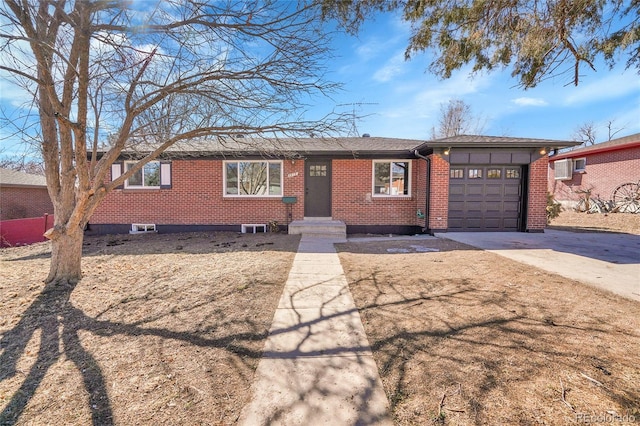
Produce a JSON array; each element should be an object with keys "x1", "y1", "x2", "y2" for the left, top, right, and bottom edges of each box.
[{"x1": 0, "y1": 284, "x2": 266, "y2": 425}]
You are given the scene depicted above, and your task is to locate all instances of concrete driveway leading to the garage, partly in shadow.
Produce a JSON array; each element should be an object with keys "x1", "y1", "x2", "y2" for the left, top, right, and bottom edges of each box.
[{"x1": 435, "y1": 230, "x2": 640, "y2": 302}]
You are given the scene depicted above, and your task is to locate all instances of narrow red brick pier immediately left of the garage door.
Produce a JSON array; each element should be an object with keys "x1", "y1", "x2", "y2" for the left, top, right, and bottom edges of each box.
[{"x1": 429, "y1": 154, "x2": 449, "y2": 230}]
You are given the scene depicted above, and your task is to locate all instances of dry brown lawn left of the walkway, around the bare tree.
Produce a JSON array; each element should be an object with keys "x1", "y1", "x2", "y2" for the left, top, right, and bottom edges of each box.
[{"x1": 0, "y1": 233, "x2": 299, "y2": 425}]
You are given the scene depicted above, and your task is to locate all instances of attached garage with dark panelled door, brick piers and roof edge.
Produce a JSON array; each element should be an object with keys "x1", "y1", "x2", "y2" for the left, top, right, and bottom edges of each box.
[{"x1": 417, "y1": 135, "x2": 575, "y2": 233}]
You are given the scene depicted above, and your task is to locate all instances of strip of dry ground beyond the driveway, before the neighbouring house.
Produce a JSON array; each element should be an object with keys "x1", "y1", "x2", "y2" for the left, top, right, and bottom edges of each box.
[{"x1": 548, "y1": 210, "x2": 640, "y2": 235}]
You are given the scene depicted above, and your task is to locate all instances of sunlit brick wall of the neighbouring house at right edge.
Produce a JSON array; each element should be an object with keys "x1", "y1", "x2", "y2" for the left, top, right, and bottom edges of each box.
[{"x1": 549, "y1": 147, "x2": 640, "y2": 202}]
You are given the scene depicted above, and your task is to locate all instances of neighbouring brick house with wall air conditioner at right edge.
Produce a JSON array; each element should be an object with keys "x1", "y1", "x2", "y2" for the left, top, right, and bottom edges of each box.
[{"x1": 549, "y1": 133, "x2": 640, "y2": 208}]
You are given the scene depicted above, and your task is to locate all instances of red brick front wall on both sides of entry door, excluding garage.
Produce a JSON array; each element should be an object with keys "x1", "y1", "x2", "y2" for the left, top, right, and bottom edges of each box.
[{"x1": 90, "y1": 159, "x2": 426, "y2": 230}]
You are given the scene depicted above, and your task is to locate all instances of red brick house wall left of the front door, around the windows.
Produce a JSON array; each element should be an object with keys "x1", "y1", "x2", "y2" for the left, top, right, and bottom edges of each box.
[{"x1": 90, "y1": 160, "x2": 304, "y2": 225}]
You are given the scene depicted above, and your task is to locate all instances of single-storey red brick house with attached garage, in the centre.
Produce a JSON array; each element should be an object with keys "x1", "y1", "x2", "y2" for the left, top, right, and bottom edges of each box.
[{"x1": 87, "y1": 136, "x2": 573, "y2": 234}]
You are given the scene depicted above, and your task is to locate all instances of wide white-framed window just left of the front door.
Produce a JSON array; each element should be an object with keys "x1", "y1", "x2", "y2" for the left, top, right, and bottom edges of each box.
[{"x1": 224, "y1": 161, "x2": 282, "y2": 197}]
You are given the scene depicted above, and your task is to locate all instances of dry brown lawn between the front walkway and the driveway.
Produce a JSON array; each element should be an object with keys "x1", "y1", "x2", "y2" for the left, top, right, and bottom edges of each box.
[{"x1": 339, "y1": 240, "x2": 640, "y2": 425}]
